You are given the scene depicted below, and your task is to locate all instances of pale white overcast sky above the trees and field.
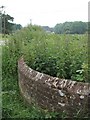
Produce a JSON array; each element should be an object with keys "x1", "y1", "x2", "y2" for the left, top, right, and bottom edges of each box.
[{"x1": 0, "y1": 0, "x2": 89, "y2": 27}]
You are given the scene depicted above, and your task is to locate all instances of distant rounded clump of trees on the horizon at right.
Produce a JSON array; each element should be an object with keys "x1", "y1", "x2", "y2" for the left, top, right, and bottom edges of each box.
[{"x1": 54, "y1": 21, "x2": 88, "y2": 34}]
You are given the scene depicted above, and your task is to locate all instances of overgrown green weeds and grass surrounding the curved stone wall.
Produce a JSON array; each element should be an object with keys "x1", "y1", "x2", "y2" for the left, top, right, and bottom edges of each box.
[{"x1": 2, "y1": 25, "x2": 88, "y2": 119}]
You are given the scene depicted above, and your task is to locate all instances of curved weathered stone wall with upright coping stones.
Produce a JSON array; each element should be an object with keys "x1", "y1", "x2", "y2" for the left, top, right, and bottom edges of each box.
[{"x1": 18, "y1": 58, "x2": 90, "y2": 116}]
